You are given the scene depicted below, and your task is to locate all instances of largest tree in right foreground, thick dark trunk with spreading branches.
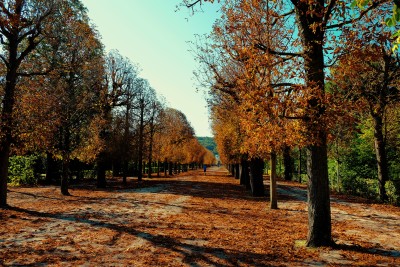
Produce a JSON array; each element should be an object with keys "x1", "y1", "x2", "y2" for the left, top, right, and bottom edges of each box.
[{"x1": 184, "y1": 0, "x2": 386, "y2": 247}]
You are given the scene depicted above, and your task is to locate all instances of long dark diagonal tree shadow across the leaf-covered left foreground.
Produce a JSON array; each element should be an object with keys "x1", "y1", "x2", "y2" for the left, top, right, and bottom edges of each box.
[{"x1": 8, "y1": 207, "x2": 285, "y2": 267}]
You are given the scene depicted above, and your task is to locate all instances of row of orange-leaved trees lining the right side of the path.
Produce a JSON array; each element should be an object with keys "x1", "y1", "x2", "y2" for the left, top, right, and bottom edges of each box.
[{"x1": 188, "y1": 0, "x2": 400, "y2": 246}]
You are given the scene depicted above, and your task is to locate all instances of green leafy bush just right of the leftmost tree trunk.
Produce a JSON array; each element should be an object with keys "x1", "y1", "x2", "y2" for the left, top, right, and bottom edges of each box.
[{"x1": 8, "y1": 155, "x2": 40, "y2": 185}]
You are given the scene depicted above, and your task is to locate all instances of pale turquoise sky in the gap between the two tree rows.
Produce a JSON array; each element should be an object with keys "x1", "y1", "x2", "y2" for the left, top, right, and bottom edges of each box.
[{"x1": 82, "y1": 0, "x2": 219, "y2": 136}]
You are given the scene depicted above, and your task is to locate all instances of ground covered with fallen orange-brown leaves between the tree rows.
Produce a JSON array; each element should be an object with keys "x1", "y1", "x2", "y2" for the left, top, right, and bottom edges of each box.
[{"x1": 0, "y1": 167, "x2": 400, "y2": 266}]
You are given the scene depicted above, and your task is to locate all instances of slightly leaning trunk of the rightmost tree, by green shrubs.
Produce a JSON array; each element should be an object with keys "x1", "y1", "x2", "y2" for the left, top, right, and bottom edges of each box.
[{"x1": 373, "y1": 116, "x2": 389, "y2": 202}]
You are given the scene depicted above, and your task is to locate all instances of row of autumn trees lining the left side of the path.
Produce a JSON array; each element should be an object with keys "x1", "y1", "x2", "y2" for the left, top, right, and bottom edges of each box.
[{"x1": 0, "y1": 0, "x2": 213, "y2": 207}]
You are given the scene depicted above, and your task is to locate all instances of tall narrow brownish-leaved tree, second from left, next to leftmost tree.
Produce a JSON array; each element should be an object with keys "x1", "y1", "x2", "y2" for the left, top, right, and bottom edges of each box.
[{"x1": 41, "y1": 2, "x2": 105, "y2": 195}]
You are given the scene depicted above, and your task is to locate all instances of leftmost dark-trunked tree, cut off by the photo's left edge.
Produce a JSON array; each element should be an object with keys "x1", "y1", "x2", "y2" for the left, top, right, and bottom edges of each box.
[{"x1": 0, "y1": 0, "x2": 59, "y2": 207}]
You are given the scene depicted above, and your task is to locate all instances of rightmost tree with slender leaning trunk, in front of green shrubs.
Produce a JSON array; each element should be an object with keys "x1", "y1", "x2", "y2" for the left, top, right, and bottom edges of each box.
[{"x1": 334, "y1": 10, "x2": 400, "y2": 202}]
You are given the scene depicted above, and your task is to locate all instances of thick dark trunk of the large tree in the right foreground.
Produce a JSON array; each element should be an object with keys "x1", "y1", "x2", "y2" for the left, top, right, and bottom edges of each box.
[{"x1": 296, "y1": 6, "x2": 333, "y2": 247}]
